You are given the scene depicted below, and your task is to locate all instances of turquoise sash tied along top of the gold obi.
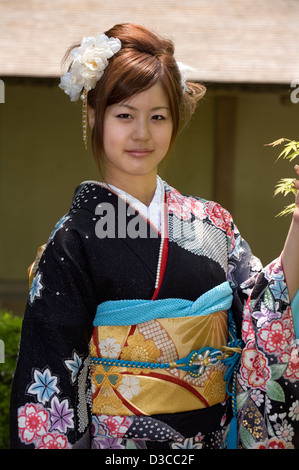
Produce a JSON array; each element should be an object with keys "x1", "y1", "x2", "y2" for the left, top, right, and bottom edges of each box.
[{"x1": 93, "y1": 281, "x2": 233, "y2": 326}]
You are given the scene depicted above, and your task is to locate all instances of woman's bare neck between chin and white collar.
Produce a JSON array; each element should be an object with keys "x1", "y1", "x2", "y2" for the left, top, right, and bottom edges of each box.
[{"x1": 105, "y1": 174, "x2": 157, "y2": 206}]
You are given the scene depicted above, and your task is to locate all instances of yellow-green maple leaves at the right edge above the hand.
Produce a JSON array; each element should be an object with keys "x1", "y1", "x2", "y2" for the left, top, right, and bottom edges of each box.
[{"x1": 268, "y1": 138, "x2": 299, "y2": 217}]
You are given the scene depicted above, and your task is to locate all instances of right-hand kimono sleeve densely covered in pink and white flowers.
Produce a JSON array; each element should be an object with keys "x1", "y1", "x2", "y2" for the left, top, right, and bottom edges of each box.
[{"x1": 229, "y1": 220, "x2": 299, "y2": 449}]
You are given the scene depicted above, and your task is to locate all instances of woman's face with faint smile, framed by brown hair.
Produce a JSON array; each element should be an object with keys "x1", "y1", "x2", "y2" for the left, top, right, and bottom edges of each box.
[{"x1": 99, "y1": 82, "x2": 173, "y2": 185}]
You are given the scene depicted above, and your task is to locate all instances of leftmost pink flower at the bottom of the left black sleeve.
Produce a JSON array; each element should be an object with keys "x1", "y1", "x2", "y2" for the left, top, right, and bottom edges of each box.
[{"x1": 18, "y1": 404, "x2": 50, "y2": 444}]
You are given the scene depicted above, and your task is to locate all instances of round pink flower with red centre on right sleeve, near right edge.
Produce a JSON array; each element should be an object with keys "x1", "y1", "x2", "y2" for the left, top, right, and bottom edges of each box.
[{"x1": 259, "y1": 321, "x2": 292, "y2": 353}]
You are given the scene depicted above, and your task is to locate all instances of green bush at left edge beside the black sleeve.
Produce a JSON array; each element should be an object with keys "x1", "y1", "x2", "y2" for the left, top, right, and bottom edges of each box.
[{"x1": 0, "y1": 311, "x2": 22, "y2": 449}]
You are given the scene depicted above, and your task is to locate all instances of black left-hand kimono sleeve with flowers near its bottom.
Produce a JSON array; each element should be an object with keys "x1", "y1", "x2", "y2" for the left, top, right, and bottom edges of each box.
[{"x1": 11, "y1": 219, "x2": 96, "y2": 449}]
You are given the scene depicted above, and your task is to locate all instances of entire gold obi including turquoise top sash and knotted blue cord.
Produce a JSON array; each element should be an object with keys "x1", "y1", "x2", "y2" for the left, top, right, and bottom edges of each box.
[{"x1": 90, "y1": 283, "x2": 241, "y2": 416}]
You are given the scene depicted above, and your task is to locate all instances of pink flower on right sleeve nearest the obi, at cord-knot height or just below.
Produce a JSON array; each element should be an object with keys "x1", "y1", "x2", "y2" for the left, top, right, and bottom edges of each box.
[{"x1": 241, "y1": 343, "x2": 271, "y2": 390}]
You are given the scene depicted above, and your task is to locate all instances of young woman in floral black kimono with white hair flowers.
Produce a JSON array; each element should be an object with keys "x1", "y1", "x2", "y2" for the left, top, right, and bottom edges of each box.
[{"x1": 11, "y1": 24, "x2": 299, "y2": 449}]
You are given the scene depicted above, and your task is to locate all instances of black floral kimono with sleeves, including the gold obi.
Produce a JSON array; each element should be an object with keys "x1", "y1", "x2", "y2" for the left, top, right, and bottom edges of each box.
[{"x1": 11, "y1": 182, "x2": 299, "y2": 449}]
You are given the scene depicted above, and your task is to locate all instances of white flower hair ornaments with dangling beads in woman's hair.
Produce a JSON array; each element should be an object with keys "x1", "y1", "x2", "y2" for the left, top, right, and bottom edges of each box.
[{"x1": 59, "y1": 34, "x2": 194, "y2": 149}]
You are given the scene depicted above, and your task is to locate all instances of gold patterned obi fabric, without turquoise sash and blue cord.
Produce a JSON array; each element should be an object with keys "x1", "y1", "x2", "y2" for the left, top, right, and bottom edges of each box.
[{"x1": 90, "y1": 311, "x2": 228, "y2": 416}]
